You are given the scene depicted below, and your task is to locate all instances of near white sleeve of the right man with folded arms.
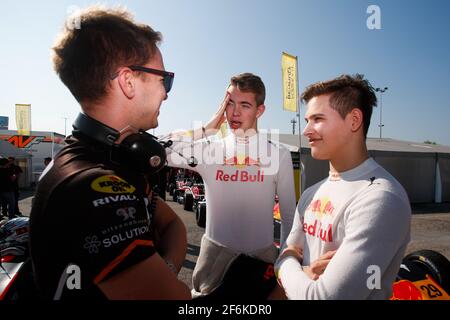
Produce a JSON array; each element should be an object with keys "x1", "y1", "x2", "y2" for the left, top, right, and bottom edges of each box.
[{"x1": 278, "y1": 191, "x2": 411, "y2": 300}]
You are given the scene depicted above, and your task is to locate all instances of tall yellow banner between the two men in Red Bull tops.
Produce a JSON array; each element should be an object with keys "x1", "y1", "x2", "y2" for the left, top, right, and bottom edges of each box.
[{"x1": 281, "y1": 52, "x2": 298, "y2": 112}]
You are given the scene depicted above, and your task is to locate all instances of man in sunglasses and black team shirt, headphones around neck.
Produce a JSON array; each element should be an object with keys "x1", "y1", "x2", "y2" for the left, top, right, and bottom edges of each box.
[{"x1": 30, "y1": 7, "x2": 190, "y2": 299}]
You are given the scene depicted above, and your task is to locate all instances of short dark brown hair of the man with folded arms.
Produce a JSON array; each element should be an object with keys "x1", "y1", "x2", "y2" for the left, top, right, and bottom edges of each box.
[{"x1": 302, "y1": 74, "x2": 377, "y2": 137}]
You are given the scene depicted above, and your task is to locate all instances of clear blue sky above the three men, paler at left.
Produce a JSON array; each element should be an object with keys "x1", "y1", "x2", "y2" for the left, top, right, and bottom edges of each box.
[{"x1": 0, "y1": 0, "x2": 450, "y2": 145}]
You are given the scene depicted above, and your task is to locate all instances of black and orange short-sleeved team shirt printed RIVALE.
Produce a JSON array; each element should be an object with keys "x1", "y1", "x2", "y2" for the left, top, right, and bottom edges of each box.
[{"x1": 30, "y1": 134, "x2": 156, "y2": 299}]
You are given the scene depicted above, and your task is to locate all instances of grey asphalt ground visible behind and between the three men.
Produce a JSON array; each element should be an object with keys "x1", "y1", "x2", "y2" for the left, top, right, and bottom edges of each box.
[{"x1": 15, "y1": 190, "x2": 450, "y2": 288}]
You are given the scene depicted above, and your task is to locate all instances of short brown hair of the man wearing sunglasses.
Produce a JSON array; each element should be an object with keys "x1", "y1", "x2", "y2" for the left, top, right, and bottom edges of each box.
[{"x1": 53, "y1": 6, "x2": 161, "y2": 102}]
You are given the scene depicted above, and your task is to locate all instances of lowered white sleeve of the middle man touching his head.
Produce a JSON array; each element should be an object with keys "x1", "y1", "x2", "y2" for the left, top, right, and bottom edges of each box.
[{"x1": 276, "y1": 150, "x2": 296, "y2": 245}]
